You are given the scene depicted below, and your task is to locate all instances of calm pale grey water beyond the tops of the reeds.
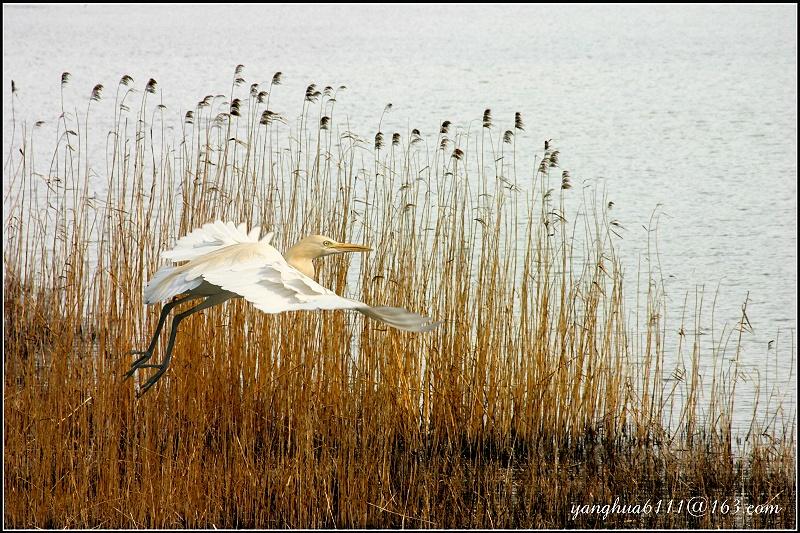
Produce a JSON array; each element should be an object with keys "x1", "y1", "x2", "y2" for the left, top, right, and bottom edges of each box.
[{"x1": 3, "y1": 6, "x2": 797, "y2": 428}]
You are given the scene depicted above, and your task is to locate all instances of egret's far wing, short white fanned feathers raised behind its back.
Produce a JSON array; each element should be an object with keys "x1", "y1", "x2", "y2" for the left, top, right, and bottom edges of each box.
[{"x1": 161, "y1": 220, "x2": 273, "y2": 262}]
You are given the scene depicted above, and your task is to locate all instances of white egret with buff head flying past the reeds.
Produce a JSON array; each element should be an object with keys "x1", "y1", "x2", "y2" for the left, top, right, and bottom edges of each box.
[{"x1": 125, "y1": 220, "x2": 441, "y2": 394}]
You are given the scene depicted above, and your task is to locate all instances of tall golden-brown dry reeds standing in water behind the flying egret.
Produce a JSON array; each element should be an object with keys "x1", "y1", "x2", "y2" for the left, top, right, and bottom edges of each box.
[{"x1": 3, "y1": 65, "x2": 796, "y2": 528}]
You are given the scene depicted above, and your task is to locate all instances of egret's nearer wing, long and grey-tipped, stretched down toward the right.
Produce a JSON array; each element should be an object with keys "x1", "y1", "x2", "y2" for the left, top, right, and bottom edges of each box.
[{"x1": 195, "y1": 243, "x2": 439, "y2": 331}]
